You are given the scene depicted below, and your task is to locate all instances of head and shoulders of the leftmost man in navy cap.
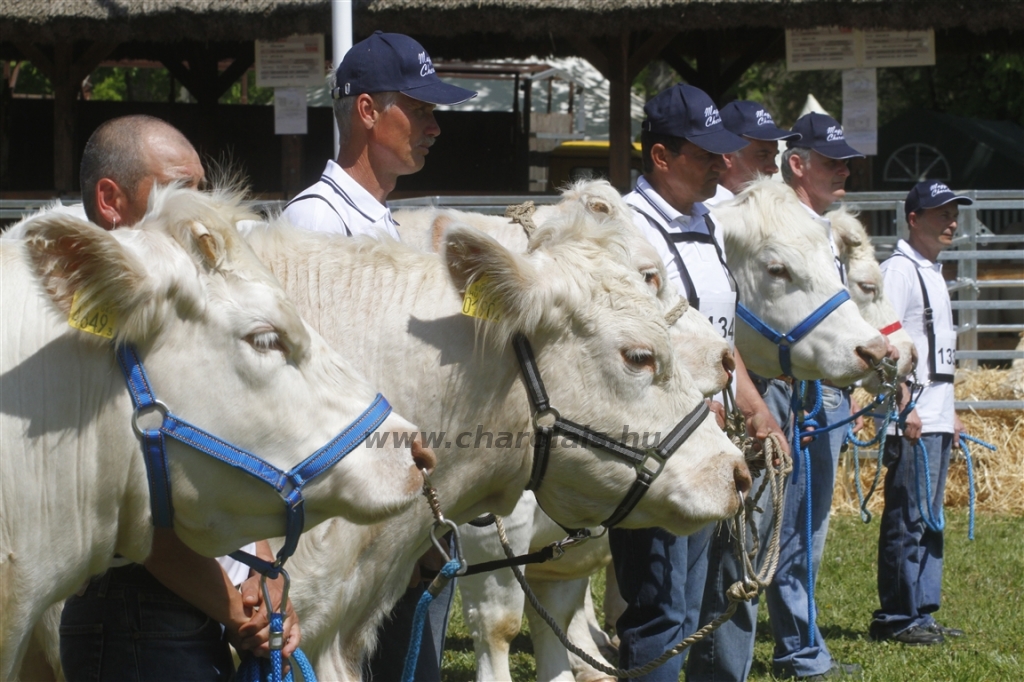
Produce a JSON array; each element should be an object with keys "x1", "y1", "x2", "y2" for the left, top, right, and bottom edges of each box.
[{"x1": 284, "y1": 31, "x2": 476, "y2": 240}]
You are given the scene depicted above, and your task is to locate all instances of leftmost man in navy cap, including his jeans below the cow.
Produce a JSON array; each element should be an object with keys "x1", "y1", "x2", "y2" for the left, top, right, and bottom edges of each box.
[{"x1": 283, "y1": 31, "x2": 476, "y2": 682}]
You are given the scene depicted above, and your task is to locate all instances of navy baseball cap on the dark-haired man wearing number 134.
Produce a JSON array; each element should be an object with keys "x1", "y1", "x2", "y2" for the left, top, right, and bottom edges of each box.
[{"x1": 643, "y1": 83, "x2": 750, "y2": 154}]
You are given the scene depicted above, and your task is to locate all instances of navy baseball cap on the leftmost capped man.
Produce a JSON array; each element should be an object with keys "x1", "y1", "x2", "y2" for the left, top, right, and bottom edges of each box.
[{"x1": 331, "y1": 31, "x2": 476, "y2": 104}]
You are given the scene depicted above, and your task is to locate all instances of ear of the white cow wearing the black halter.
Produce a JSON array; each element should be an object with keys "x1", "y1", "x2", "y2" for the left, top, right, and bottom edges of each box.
[{"x1": 440, "y1": 224, "x2": 537, "y2": 327}]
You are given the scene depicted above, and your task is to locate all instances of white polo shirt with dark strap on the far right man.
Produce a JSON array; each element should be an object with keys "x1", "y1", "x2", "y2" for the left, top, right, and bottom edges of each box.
[{"x1": 882, "y1": 240, "x2": 956, "y2": 433}]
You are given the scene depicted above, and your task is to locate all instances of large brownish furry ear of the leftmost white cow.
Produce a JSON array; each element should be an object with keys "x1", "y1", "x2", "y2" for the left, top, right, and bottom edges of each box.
[{"x1": 25, "y1": 213, "x2": 148, "y2": 318}]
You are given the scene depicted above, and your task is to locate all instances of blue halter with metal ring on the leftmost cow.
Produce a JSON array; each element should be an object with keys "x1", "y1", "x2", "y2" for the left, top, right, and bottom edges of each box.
[{"x1": 117, "y1": 344, "x2": 391, "y2": 579}]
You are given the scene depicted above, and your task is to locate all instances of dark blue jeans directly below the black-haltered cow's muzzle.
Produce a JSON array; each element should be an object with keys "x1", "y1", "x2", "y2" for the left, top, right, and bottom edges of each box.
[{"x1": 608, "y1": 523, "x2": 715, "y2": 682}]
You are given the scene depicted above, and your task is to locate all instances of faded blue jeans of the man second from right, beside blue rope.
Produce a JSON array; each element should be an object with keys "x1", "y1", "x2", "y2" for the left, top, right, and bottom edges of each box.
[{"x1": 765, "y1": 386, "x2": 850, "y2": 677}]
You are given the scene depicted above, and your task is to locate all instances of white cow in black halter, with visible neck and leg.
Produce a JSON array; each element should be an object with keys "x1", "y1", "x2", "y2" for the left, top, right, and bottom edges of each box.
[{"x1": 240, "y1": 204, "x2": 748, "y2": 680}]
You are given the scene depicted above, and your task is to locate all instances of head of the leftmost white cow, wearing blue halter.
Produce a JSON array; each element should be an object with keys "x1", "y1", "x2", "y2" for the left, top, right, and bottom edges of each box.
[{"x1": 25, "y1": 187, "x2": 433, "y2": 556}]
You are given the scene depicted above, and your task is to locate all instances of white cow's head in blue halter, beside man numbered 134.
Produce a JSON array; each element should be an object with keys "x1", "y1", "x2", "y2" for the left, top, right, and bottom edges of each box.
[{"x1": 714, "y1": 179, "x2": 886, "y2": 385}]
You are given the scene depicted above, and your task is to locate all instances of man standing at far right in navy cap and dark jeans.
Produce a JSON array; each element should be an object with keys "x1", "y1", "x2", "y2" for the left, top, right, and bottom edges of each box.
[{"x1": 870, "y1": 180, "x2": 974, "y2": 645}]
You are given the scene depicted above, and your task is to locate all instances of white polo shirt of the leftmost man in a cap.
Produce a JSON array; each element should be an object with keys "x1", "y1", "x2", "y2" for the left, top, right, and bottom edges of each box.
[{"x1": 282, "y1": 161, "x2": 401, "y2": 242}]
